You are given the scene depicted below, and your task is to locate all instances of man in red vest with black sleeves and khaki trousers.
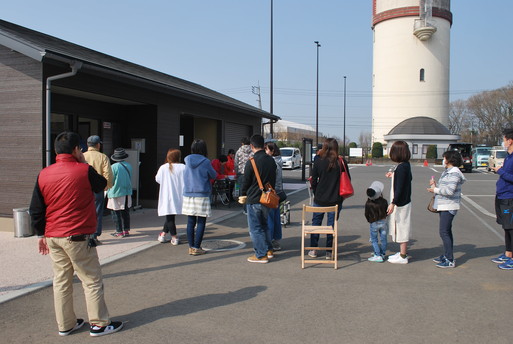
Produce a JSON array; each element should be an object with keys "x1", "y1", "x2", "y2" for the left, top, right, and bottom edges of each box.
[{"x1": 30, "y1": 132, "x2": 123, "y2": 337}]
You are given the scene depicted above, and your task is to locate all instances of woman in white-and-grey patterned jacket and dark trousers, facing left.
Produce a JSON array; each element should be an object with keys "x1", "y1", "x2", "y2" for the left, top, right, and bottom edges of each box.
[{"x1": 427, "y1": 151, "x2": 466, "y2": 268}]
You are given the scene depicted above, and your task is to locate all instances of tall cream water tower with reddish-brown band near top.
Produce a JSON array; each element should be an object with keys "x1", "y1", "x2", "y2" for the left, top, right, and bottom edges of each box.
[{"x1": 372, "y1": 0, "x2": 455, "y2": 153}]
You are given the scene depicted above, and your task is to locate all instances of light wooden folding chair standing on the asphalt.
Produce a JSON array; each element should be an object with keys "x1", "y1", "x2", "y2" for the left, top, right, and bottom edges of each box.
[{"x1": 301, "y1": 204, "x2": 338, "y2": 269}]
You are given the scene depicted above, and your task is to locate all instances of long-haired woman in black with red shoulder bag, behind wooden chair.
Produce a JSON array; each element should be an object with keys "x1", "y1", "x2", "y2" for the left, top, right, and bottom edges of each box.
[{"x1": 308, "y1": 138, "x2": 351, "y2": 259}]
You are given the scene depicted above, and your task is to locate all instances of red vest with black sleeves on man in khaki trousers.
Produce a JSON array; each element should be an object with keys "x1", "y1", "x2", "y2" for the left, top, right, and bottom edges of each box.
[{"x1": 30, "y1": 154, "x2": 107, "y2": 237}]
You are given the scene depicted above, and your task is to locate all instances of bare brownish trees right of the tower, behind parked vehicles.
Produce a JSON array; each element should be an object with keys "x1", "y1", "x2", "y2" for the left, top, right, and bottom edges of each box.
[{"x1": 449, "y1": 83, "x2": 513, "y2": 146}]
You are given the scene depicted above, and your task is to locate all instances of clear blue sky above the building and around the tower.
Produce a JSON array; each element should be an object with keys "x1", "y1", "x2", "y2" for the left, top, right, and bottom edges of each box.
[{"x1": 0, "y1": 0, "x2": 513, "y2": 141}]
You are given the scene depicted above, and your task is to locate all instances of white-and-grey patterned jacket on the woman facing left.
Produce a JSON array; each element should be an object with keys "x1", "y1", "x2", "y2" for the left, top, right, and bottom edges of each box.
[{"x1": 433, "y1": 167, "x2": 466, "y2": 211}]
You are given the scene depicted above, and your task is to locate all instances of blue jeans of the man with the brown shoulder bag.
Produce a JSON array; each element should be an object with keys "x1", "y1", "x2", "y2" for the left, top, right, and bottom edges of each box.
[{"x1": 247, "y1": 203, "x2": 273, "y2": 258}]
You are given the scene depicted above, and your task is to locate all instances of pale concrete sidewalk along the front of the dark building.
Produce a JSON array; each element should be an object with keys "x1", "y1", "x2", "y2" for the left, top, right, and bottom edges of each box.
[{"x1": 0, "y1": 184, "x2": 304, "y2": 303}]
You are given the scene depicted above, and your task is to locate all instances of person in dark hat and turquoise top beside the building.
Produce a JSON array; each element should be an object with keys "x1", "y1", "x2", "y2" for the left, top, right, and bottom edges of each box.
[{"x1": 107, "y1": 148, "x2": 132, "y2": 238}]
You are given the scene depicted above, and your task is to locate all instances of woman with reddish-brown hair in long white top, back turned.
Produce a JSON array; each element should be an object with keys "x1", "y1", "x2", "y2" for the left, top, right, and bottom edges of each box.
[{"x1": 155, "y1": 149, "x2": 185, "y2": 245}]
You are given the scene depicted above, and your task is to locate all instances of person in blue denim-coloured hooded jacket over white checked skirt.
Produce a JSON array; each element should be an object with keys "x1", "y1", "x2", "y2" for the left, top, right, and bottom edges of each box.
[{"x1": 182, "y1": 139, "x2": 217, "y2": 256}]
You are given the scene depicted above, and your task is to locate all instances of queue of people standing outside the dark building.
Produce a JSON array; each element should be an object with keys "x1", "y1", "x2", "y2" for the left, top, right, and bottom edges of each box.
[{"x1": 30, "y1": 129, "x2": 513, "y2": 336}]
